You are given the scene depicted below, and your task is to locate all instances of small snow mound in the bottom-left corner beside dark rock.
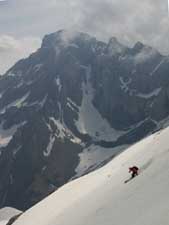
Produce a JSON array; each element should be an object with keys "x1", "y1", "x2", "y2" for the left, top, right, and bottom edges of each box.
[{"x1": 0, "y1": 207, "x2": 21, "y2": 221}]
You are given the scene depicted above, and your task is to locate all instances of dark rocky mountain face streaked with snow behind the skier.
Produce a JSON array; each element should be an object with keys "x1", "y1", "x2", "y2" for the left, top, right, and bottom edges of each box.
[{"x1": 0, "y1": 31, "x2": 169, "y2": 209}]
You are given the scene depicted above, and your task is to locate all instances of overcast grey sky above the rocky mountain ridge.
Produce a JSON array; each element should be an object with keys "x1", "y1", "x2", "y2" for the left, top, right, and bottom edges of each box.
[{"x1": 0, "y1": 0, "x2": 169, "y2": 74}]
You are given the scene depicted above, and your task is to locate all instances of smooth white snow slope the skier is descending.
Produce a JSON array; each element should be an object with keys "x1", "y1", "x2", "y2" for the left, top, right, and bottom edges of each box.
[{"x1": 14, "y1": 128, "x2": 169, "y2": 225}]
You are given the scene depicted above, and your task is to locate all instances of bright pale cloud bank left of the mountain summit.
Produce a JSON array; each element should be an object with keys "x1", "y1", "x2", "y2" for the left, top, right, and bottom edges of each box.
[{"x1": 0, "y1": 35, "x2": 41, "y2": 74}]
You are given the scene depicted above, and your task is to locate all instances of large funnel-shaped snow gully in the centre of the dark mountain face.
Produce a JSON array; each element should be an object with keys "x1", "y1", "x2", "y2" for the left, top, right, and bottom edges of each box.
[{"x1": 75, "y1": 66, "x2": 125, "y2": 141}]
